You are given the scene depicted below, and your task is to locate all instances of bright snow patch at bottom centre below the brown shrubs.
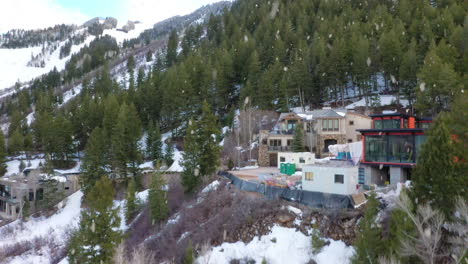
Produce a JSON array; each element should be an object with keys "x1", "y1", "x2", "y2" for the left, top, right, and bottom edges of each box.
[{"x1": 197, "y1": 225, "x2": 354, "y2": 264}]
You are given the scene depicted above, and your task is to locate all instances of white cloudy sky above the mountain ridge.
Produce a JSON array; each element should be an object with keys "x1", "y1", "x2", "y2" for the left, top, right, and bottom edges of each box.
[{"x1": 0, "y1": 0, "x2": 227, "y2": 33}]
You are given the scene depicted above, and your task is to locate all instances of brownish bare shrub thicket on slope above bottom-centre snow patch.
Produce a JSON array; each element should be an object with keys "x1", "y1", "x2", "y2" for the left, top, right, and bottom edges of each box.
[{"x1": 145, "y1": 181, "x2": 279, "y2": 263}]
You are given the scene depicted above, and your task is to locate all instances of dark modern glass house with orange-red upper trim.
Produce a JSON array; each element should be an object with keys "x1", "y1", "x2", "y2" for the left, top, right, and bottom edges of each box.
[{"x1": 357, "y1": 113, "x2": 432, "y2": 185}]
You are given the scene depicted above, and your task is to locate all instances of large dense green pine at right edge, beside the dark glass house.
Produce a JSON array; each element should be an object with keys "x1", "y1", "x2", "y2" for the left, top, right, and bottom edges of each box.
[{"x1": 411, "y1": 116, "x2": 468, "y2": 218}]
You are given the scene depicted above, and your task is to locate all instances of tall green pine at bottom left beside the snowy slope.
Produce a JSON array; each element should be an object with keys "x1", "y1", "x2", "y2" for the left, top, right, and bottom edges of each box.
[{"x1": 68, "y1": 176, "x2": 122, "y2": 264}]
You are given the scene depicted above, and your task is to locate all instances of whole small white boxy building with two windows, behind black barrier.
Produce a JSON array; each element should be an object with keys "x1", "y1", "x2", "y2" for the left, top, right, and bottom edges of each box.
[{"x1": 302, "y1": 160, "x2": 360, "y2": 195}]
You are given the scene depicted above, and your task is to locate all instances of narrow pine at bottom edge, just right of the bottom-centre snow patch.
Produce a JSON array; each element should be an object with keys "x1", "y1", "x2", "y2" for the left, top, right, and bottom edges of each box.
[{"x1": 352, "y1": 192, "x2": 384, "y2": 264}]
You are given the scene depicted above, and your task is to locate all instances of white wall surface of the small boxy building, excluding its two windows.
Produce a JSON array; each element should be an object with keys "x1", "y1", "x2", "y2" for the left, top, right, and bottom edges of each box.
[{"x1": 302, "y1": 165, "x2": 358, "y2": 195}]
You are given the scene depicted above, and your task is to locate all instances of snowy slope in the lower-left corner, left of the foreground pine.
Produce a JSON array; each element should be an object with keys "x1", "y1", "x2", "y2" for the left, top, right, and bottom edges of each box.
[{"x1": 0, "y1": 191, "x2": 83, "y2": 264}]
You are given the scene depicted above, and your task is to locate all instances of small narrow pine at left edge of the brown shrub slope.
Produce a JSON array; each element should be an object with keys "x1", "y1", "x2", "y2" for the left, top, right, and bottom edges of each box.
[{"x1": 148, "y1": 172, "x2": 169, "y2": 224}]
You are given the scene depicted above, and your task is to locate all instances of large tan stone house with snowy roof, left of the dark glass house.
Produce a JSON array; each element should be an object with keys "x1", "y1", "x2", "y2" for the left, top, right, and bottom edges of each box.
[{"x1": 258, "y1": 108, "x2": 372, "y2": 166}]
